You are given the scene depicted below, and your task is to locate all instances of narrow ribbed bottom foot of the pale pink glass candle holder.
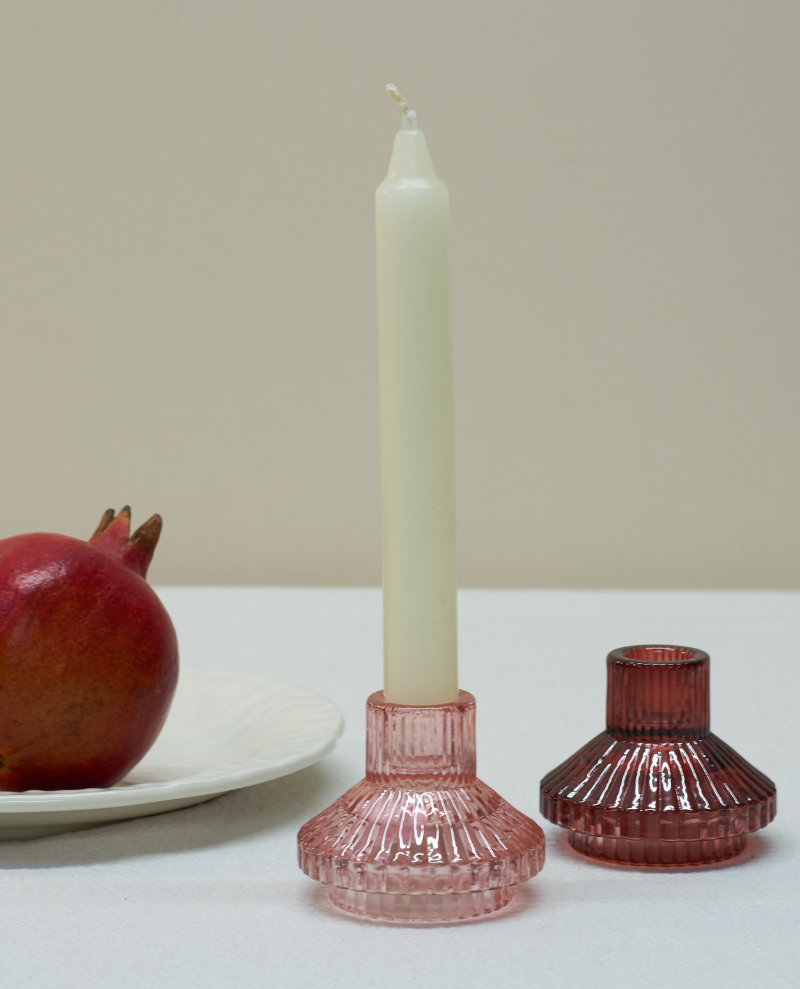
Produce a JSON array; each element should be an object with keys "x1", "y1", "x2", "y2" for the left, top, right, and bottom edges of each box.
[{"x1": 328, "y1": 886, "x2": 514, "y2": 924}]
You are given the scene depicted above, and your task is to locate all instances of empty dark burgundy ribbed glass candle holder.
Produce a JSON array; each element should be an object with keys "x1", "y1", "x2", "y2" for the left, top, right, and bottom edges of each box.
[{"x1": 541, "y1": 646, "x2": 775, "y2": 867}]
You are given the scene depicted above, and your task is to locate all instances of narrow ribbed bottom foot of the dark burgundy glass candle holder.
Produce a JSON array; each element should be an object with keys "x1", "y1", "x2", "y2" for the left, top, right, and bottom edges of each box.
[{"x1": 569, "y1": 831, "x2": 747, "y2": 869}]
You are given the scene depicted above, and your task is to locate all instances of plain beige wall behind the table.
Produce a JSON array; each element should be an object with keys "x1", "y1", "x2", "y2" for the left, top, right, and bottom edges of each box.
[{"x1": 0, "y1": 0, "x2": 800, "y2": 588}]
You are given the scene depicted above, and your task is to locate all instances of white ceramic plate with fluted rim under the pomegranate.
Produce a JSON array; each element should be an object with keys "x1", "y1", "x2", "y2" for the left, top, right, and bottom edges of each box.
[{"x1": 0, "y1": 666, "x2": 344, "y2": 841}]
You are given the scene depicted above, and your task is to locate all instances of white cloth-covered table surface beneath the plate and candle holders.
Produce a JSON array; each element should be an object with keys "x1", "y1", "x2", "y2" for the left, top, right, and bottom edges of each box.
[{"x1": 0, "y1": 587, "x2": 800, "y2": 989}]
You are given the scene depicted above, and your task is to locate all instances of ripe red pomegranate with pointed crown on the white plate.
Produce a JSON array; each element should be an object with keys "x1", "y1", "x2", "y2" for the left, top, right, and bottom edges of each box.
[{"x1": 0, "y1": 507, "x2": 178, "y2": 791}]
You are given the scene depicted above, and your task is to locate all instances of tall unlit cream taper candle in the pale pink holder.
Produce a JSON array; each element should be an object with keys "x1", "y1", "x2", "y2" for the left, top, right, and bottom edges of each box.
[{"x1": 376, "y1": 94, "x2": 458, "y2": 705}]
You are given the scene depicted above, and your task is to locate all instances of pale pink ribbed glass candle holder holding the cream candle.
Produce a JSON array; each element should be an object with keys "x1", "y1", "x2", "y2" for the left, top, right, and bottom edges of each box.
[{"x1": 297, "y1": 690, "x2": 544, "y2": 924}]
